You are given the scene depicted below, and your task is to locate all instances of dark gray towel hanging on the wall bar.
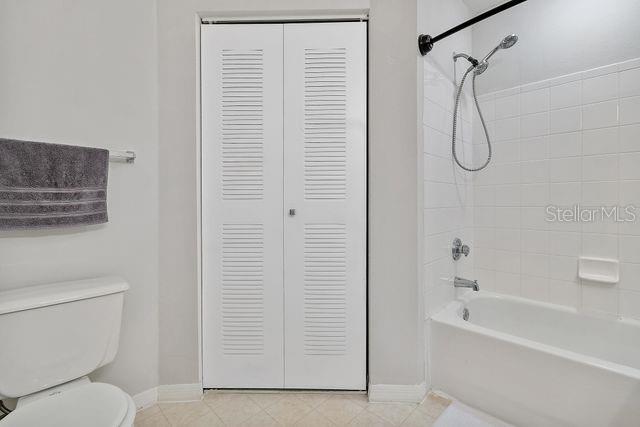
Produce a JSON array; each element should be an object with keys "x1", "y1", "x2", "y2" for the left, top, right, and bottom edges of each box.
[{"x1": 0, "y1": 138, "x2": 109, "y2": 230}]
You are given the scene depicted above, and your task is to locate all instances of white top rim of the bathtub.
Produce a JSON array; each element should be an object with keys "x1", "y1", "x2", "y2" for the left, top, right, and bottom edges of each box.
[{"x1": 430, "y1": 291, "x2": 640, "y2": 381}]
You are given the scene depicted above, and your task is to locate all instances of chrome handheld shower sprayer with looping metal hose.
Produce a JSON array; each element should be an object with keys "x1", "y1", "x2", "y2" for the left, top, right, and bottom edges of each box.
[{"x1": 451, "y1": 34, "x2": 518, "y2": 172}]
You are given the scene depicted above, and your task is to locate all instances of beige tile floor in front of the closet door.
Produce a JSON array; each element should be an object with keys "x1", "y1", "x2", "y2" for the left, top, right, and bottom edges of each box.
[{"x1": 135, "y1": 391, "x2": 451, "y2": 427}]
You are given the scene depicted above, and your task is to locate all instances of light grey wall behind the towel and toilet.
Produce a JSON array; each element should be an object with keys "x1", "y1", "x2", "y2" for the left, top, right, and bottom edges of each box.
[{"x1": 0, "y1": 0, "x2": 158, "y2": 394}]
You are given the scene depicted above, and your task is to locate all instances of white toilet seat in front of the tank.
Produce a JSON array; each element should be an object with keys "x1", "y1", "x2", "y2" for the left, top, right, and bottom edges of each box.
[{"x1": 0, "y1": 383, "x2": 135, "y2": 427}]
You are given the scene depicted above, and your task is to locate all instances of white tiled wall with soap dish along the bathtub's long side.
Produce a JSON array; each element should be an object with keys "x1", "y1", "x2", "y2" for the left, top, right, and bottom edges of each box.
[{"x1": 470, "y1": 56, "x2": 640, "y2": 319}]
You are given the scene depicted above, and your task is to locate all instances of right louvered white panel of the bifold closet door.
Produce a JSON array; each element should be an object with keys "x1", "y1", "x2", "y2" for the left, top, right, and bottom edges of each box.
[{"x1": 284, "y1": 22, "x2": 367, "y2": 390}]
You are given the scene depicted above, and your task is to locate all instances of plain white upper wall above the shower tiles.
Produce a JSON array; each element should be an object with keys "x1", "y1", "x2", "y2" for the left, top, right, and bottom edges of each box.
[{"x1": 473, "y1": 0, "x2": 640, "y2": 93}]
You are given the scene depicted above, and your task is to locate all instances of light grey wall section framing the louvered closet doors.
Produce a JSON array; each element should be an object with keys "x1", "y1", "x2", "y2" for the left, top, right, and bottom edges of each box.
[{"x1": 158, "y1": 0, "x2": 424, "y2": 392}]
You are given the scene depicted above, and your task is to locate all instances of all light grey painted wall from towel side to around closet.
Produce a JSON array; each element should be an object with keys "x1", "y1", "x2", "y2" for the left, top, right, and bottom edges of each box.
[{"x1": 0, "y1": 0, "x2": 424, "y2": 394}]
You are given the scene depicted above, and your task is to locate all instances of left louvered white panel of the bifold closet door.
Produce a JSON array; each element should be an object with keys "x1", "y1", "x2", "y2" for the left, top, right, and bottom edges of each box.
[{"x1": 201, "y1": 24, "x2": 284, "y2": 388}]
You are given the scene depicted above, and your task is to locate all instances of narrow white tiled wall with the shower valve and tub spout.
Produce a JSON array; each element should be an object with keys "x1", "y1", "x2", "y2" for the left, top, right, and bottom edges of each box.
[{"x1": 423, "y1": 59, "x2": 476, "y2": 316}]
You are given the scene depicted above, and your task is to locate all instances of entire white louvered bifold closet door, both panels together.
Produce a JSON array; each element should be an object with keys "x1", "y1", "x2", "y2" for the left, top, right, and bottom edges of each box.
[{"x1": 201, "y1": 22, "x2": 367, "y2": 390}]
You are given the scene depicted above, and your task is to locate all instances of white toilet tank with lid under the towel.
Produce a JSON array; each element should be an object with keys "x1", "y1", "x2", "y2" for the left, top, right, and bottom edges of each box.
[{"x1": 0, "y1": 277, "x2": 129, "y2": 398}]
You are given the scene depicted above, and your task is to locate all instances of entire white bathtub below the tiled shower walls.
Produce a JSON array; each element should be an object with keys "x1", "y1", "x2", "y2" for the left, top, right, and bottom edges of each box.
[{"x1": 430, "y1": 292, "x2": 640, "y2": 427}]
